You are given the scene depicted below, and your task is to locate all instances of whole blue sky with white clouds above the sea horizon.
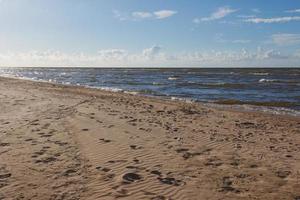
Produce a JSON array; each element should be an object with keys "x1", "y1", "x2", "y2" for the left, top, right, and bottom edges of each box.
[{"x1": 0, "y1": 0, "x2": 300, "y2": 67}]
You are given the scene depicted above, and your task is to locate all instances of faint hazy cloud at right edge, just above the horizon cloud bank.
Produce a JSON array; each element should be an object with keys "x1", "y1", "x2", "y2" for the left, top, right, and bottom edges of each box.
[{"x1": 271, "y1": 33, "x2": 300, "y2": 46}]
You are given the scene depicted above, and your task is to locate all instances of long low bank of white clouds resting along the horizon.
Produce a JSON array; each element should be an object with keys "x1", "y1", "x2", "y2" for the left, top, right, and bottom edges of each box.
[{"x1": 0, "y1": 45, "x2": 300, "y2": 67}]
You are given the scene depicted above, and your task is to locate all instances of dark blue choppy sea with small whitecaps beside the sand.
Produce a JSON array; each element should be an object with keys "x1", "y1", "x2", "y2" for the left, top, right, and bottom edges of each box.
[{"x1": 0, "y1": 67, "x2": 300, "y2": 116}]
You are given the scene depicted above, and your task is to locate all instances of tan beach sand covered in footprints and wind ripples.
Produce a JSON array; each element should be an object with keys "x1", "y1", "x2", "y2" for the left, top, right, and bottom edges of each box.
[{"x1": 0, "y1": 78, "x2": 300, "y2": 200}]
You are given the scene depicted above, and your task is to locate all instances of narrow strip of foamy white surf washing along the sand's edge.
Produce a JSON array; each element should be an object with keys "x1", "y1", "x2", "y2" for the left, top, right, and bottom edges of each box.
[{"x1": 0, "y1": 76, "x2": 300, "y2": 118}]
